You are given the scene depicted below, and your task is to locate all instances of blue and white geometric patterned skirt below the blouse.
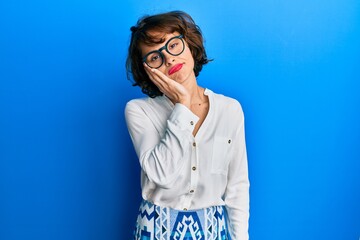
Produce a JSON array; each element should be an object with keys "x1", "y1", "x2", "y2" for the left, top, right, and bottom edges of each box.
[{"x1": 133, "y1": 200, "x2": 231, "y2": 240}]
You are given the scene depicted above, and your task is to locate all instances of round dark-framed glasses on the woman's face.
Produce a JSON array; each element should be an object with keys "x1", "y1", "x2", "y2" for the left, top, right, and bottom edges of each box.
[{"x1": 143, "y1": 35, "x2": 185, "y2": 68}]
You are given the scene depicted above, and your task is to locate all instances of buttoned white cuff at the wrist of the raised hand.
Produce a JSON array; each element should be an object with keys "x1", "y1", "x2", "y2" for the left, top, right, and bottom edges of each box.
[{"x1": 169, "y1": 103, "x2": 199, "y2": 131}]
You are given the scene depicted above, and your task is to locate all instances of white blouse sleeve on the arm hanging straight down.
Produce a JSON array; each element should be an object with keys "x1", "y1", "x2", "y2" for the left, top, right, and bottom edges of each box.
[{"x1": 224, "y1": 107, "x2": 250, "y2": 240}]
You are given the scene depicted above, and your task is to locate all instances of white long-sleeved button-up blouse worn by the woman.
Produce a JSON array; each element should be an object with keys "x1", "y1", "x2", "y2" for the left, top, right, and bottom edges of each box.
[{"x1": 125, "y1": 89, "x2": 249, "y2": 240}]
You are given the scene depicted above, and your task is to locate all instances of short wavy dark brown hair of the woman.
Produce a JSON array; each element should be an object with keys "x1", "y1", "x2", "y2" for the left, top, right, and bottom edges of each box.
[{"x1": 126, "y1": 11, "x2": 211, "y2": 98}]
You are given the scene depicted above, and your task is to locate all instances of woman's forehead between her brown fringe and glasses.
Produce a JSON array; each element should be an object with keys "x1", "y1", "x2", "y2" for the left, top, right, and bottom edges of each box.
[{"x1": 139, "y1": 32, "x2": 179, "y2": 55}]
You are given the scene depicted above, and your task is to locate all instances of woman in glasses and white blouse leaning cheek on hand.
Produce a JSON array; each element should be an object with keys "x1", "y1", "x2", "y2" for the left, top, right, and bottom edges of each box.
[{"x1": 125, "y1": 11, "x2": 249, "y2": 240}]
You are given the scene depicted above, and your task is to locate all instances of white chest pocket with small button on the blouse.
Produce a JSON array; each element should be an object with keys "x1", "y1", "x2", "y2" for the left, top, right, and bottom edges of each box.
[{"x1": 211, "y1": 136, "x2": 232, "y2": 174}]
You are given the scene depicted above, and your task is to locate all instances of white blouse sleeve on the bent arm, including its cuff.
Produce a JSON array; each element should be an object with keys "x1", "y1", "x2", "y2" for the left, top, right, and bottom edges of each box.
[{"x1": 125, "y1": 101, "x2": 199, "y2": 188}]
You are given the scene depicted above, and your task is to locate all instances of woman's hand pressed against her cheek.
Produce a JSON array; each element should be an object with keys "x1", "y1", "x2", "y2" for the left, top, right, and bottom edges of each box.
[{"x1": 144, "y1": 63, "x2": 191, "y2": 109}]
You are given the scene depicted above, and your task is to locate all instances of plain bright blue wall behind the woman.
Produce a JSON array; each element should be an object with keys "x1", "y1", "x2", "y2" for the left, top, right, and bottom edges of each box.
[{"x1": 0, "y1": 0, "x2": 360, "y2": 240}]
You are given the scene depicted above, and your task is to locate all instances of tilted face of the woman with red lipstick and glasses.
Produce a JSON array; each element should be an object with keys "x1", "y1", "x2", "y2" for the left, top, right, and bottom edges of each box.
[{"x1": 140, "y1": 32, "x2": 195, "y2": 83}]
